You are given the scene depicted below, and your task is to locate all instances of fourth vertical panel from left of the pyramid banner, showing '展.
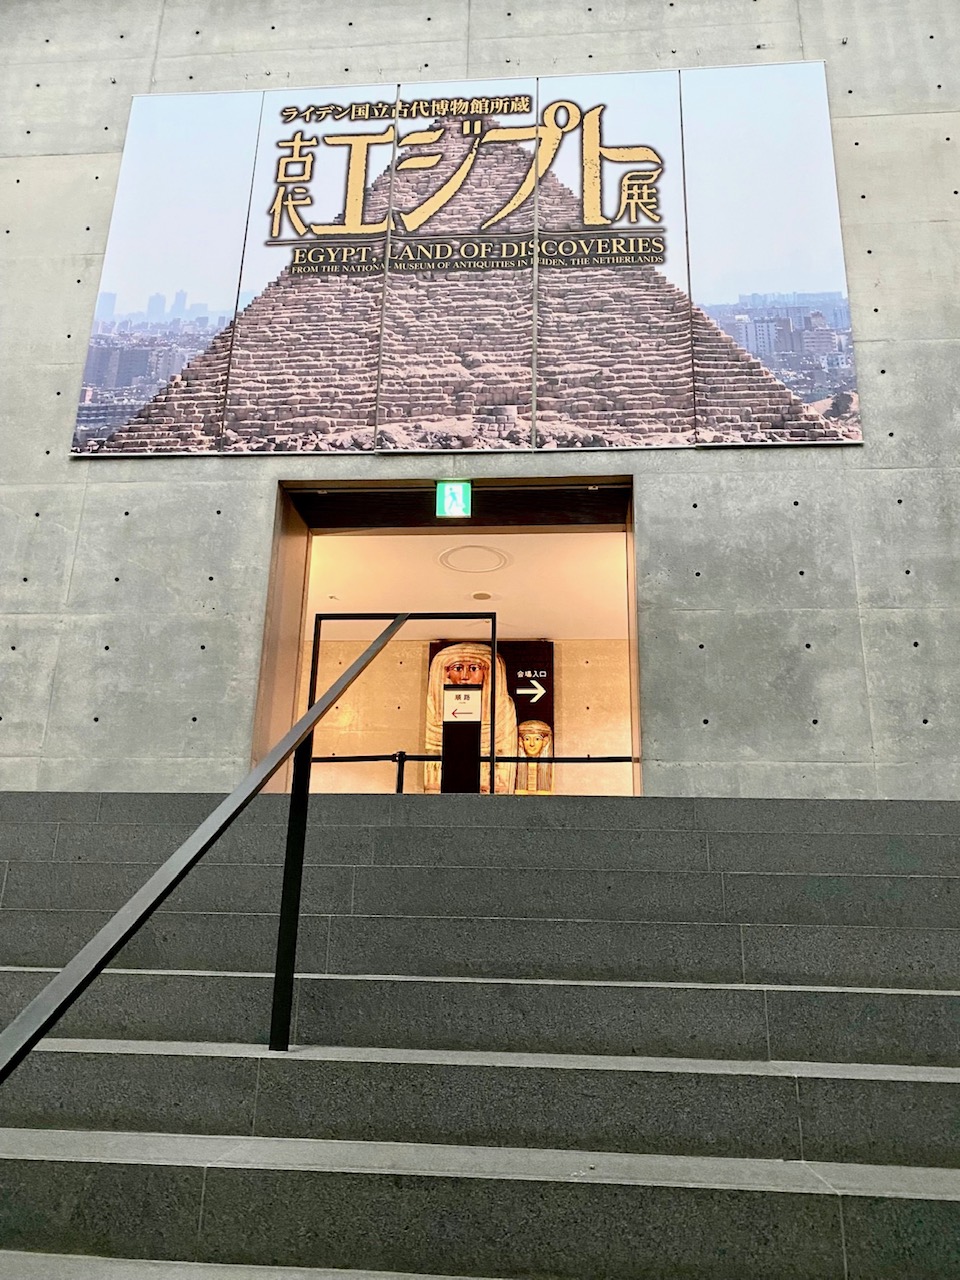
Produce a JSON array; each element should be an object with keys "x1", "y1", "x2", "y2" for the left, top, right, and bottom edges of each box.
[{"x1": 536, "y1": 72, "x2": 696, "y2": 449}]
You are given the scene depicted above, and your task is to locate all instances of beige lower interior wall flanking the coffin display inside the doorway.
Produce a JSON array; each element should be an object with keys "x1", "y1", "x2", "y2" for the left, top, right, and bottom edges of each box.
[{"x1": 301, "y1": 640, "x2": 634, "y2": 795}]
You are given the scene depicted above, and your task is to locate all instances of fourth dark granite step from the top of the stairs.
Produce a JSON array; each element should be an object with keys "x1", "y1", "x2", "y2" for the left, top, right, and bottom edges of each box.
[{"x1": 0, "y1": 909, "x2": 960, "y2": 989}]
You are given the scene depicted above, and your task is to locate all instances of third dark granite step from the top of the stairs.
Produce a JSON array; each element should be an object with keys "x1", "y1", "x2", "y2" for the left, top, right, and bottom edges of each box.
[{"x1": 0, "y1": 861, "x2": 960, "y2": 928}]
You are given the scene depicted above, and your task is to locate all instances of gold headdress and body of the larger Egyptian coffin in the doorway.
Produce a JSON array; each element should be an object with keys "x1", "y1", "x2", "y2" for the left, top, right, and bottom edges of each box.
[{"x1": 424, "y1": 641, "x2": 517, "y2": 795}]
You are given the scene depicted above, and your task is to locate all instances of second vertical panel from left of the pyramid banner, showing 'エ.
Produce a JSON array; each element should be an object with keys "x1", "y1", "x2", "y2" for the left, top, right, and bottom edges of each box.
[{"x1": 223, "y1": 84, "x2": 397, "y2": 453}]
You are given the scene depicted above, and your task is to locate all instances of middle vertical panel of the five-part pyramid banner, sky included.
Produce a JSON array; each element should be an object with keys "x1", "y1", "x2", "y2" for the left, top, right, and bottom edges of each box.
[{"x1": 378, "y1": 79, "x2": 538, "y2": 451}]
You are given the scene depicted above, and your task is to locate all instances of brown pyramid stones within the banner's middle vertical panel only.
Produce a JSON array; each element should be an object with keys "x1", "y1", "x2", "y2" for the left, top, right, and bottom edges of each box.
[{"x1": 370, "y1": 118, "x2": 534, "y2": 449}]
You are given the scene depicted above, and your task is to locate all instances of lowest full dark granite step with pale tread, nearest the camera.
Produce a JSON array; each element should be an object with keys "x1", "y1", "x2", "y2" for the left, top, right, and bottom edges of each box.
[{"x1": 0, "y1": 1129, "x2": 960, "y2": 1280}]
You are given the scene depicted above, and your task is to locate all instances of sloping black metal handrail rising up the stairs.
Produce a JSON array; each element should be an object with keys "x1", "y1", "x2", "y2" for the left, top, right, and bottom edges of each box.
[{"x1": 0, "y1": 613, "x2": 411, "y2": 1084}]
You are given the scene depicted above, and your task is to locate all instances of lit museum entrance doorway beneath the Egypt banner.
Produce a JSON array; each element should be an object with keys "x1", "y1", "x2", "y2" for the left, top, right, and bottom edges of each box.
[{"x1": 255, "y1": 477, "x2": 640, "y2": 795}]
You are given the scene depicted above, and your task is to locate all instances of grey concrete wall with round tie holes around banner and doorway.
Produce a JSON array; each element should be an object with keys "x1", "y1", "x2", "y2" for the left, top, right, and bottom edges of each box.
[{"x1": 0, "y1": 0, "x2": 960, "y2": 797}]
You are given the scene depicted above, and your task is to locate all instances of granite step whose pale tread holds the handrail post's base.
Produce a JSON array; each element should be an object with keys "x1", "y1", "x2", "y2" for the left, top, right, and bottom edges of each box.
[{"x1": 0, "y1": 1038, "x2": 960, "y2": 1167}]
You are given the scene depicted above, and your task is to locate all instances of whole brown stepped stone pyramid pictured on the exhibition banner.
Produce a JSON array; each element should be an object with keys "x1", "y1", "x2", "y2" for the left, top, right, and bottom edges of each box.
[{"x1": 87, "y1": 118, "x2": 852, "y2": 452}]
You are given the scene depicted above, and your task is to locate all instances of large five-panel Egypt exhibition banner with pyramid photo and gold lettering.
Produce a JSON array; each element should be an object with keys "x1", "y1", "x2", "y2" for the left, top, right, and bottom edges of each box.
[{"x1": 74, "y1": 63, "x2": 861, "y2": 456}]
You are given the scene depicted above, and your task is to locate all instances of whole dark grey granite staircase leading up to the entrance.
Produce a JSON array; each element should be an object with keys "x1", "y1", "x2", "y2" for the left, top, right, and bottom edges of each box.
[{"x1": 0, "y1": 794, "x2": 960, "y2": 1280}]
